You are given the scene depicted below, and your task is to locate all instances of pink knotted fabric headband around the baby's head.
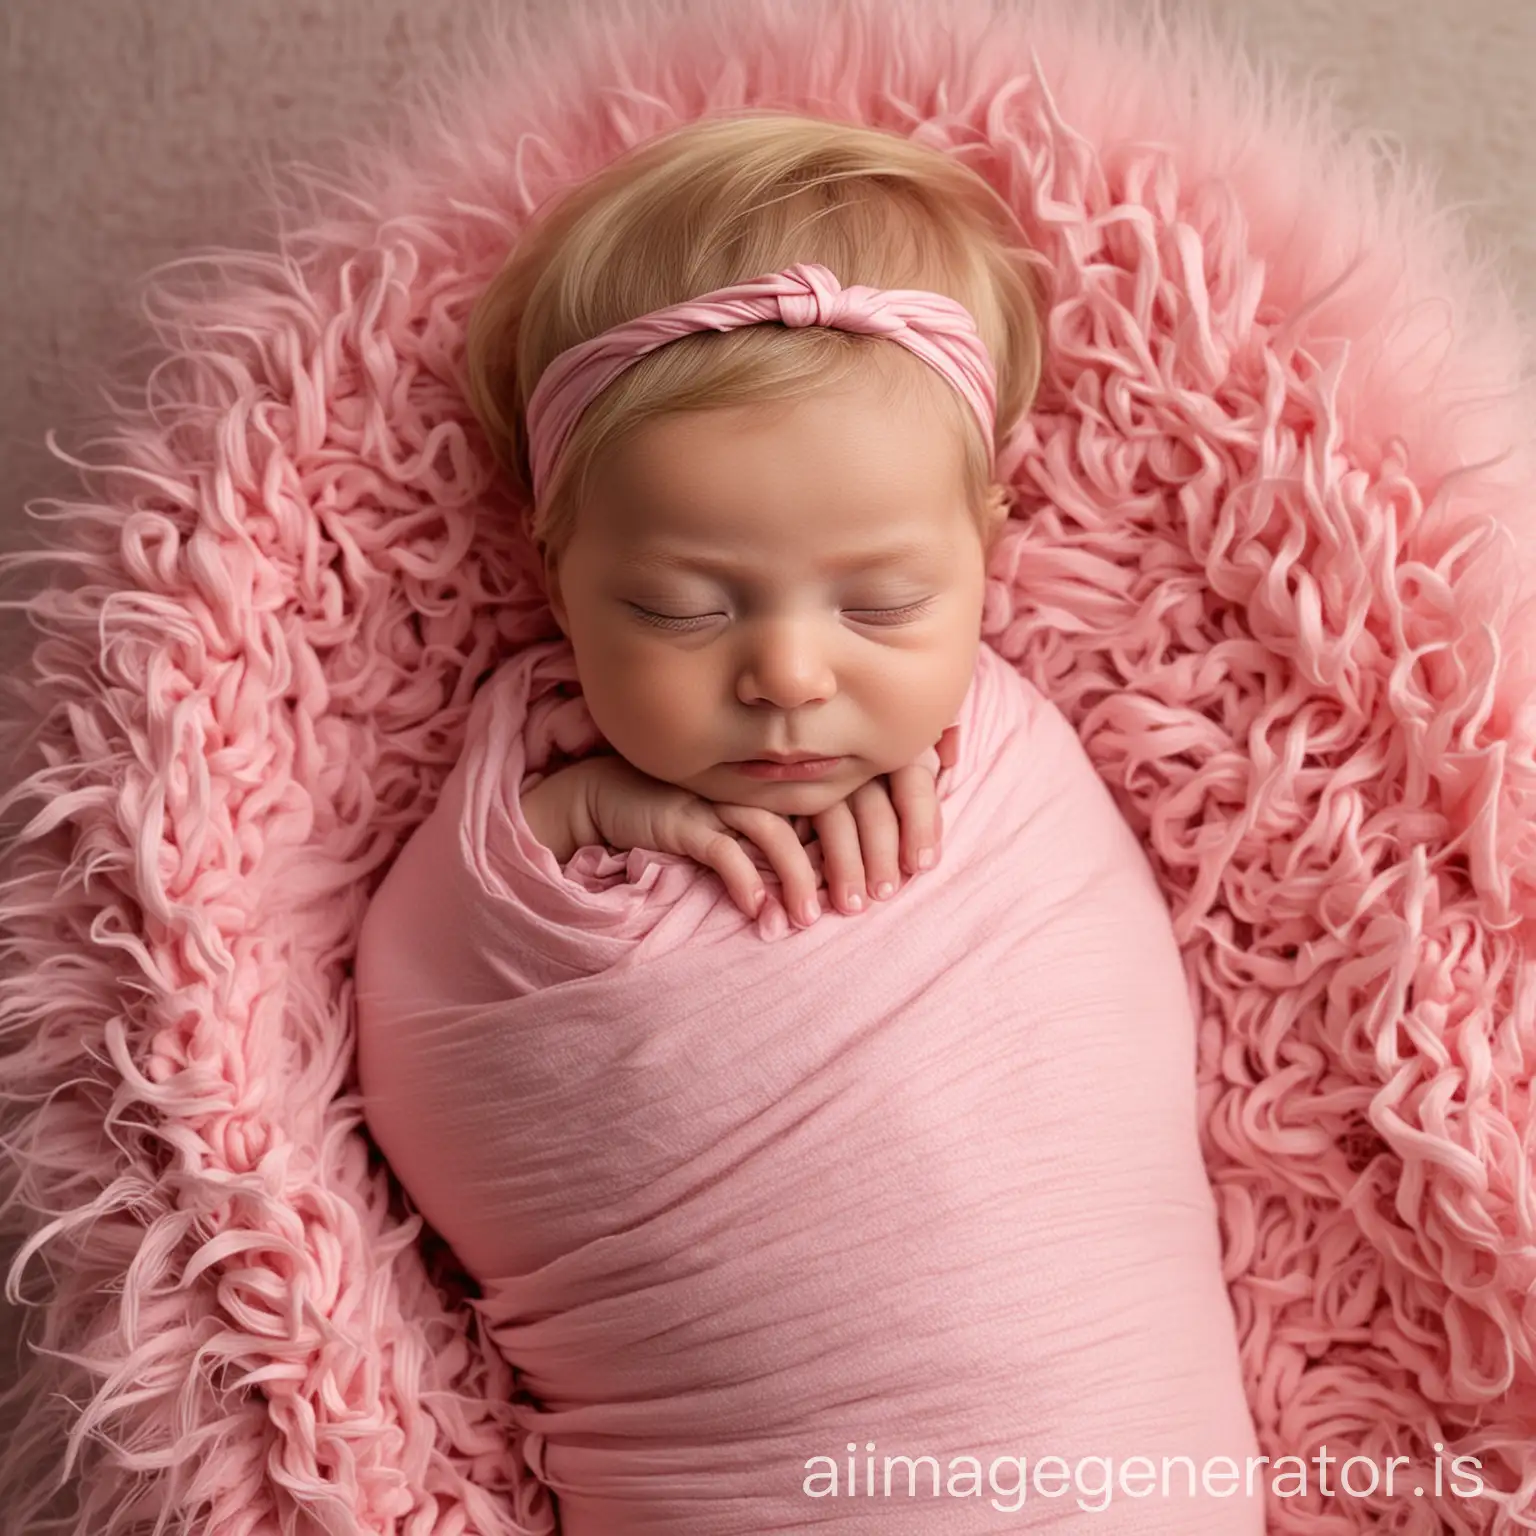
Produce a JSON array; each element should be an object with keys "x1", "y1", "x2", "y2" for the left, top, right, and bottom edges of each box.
[{"x1": 528, "y1": 261, "x2": 997, "y2": 501}]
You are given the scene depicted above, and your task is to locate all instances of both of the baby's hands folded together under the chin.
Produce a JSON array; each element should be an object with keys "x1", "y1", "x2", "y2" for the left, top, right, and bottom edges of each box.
[{"x1": 562, "y1": 727, "x2": 954, "y2": 926}]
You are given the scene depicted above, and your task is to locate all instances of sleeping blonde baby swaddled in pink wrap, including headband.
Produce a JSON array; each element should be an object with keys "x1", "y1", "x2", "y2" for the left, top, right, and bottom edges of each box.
[{"x1": 356, "y1": 112, "x2": 1267, "y2": 1536}]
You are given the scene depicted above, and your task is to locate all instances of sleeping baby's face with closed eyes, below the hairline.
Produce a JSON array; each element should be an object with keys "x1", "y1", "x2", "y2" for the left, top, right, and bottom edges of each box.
[{"x1": 547, "y1": 362, "x2": 986, "y2": 816}]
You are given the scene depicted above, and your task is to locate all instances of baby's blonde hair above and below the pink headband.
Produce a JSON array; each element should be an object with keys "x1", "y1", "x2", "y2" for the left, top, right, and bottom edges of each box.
[{"x1": 467, "y1": 109, "x2": 1041, "y2": 558}]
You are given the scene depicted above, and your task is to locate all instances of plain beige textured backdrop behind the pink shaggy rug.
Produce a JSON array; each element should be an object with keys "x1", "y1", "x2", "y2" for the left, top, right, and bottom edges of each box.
[{"x1": 0, "y1": 0, "x2": 1536, "y2": 1499}]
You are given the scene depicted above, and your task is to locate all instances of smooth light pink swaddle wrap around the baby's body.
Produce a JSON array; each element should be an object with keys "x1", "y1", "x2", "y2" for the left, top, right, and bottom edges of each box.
[{"x1": 356, "y1": 642, "x2": 1263, "y2": 1536}]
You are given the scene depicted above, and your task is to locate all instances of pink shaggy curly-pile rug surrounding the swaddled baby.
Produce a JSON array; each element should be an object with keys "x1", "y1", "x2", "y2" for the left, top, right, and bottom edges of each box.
[{"x1": 0, "y1": 0, "x2": 1536, "y2": 1536}]
